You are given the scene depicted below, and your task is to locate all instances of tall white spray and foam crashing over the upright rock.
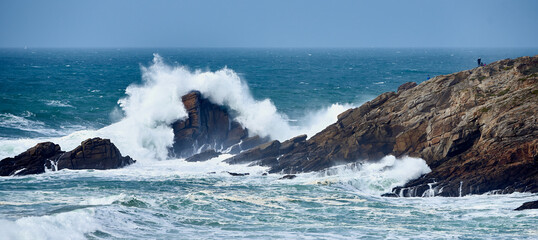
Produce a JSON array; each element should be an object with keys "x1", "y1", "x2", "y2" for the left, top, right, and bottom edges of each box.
[{"x1": 0, "y1": 54, "x2": 353, "y2": 162}]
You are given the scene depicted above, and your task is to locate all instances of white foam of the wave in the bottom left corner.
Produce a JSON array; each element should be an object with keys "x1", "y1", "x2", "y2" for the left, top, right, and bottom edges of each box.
[{"x1": 0, "y1": 209, "x2": 99, "y2": 240}]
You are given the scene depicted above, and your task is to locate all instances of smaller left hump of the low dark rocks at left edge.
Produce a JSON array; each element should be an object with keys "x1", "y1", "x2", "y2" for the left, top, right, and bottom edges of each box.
[{"x1": 0, "y1": 142, "x2": 63, "y2": 176}]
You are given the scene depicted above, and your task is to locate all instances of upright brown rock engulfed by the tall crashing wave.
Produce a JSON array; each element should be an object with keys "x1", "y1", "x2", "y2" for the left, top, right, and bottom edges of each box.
[{"x1": 171, "y1": 91, "x2": 248, "y2": 157}]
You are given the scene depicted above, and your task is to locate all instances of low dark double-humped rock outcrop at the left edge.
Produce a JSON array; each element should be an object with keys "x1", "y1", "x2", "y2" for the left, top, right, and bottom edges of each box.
[{"x1": 0, "y1": 138, "x2": 135, "y2": 176}]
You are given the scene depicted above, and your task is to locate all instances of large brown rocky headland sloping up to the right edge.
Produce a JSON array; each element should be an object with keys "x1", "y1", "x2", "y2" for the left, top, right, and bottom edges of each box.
[{"x1": 270, "y1": 56, "x2": 538, "y2": 196}]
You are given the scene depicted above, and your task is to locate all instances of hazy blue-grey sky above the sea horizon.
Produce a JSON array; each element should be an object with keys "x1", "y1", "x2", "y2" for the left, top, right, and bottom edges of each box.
[{"x1": 0, "y1": 0, "x2": 538, "y2": 47}]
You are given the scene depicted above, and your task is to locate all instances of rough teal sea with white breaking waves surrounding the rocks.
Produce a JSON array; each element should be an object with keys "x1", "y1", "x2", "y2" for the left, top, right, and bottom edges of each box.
[{"x1": 0, "y1": 48, "x2": 538, "y2": 240}]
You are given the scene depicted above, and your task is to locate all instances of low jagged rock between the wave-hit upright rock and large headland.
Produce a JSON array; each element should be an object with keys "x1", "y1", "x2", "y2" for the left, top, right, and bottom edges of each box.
[{"x1": 224, "y1": 135, "x2": 306, "y2": 166}]
